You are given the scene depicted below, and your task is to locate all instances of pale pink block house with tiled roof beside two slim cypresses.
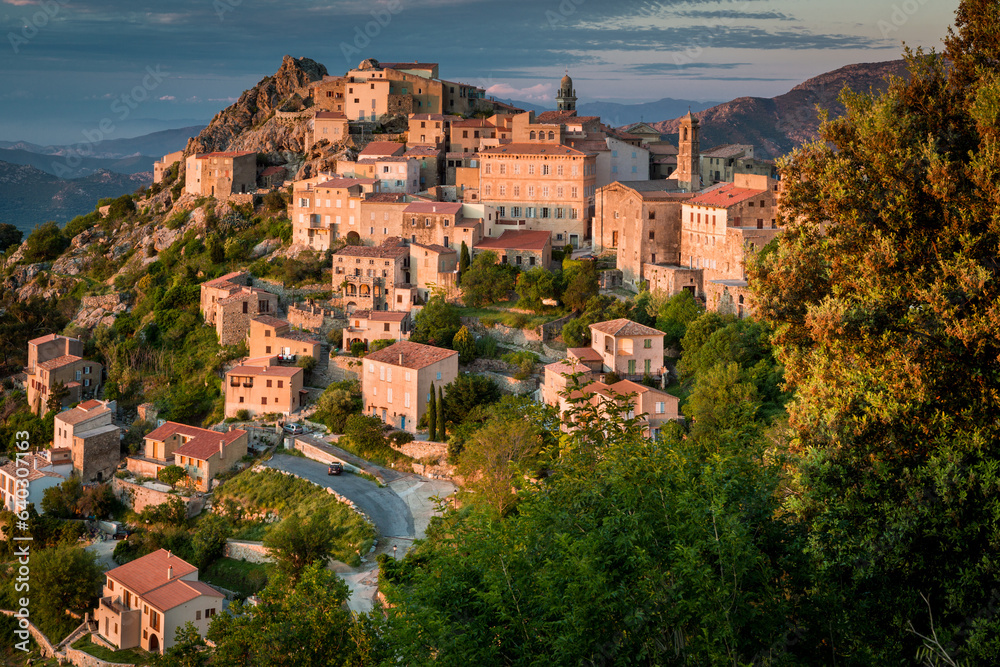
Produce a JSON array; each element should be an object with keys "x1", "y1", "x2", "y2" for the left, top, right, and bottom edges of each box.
[{"x1": 361, "y1": 341, "x2": 458, "y2": 433}]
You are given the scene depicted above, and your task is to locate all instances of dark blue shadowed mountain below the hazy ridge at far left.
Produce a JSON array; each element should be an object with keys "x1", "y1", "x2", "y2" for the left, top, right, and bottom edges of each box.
[{"x1": 0, "y1": 161, "x2": 153, "y2": 236}]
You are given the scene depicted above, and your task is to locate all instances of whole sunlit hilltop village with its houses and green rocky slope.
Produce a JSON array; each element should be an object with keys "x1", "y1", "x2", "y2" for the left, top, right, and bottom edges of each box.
[{"x1": 0, "y1": 58, "x2": 782, "y2": 664}]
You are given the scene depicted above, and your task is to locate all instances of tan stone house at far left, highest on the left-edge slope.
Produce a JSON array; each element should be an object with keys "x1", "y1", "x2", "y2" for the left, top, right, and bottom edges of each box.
[{"x1": 25, "y1": 334, "x2": 104, "y2": 415}]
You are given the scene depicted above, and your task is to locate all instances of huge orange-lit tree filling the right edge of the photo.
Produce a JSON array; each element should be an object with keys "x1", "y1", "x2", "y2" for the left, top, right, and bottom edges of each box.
[{"x1": 748, "y1": 15, "x2": 1000, "y2": 665}]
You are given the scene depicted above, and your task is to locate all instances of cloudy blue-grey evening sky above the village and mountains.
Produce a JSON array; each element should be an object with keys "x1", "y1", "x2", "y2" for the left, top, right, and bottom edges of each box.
[{"x1": 0, "y1": 0, "x2": 959, "y2": 145}]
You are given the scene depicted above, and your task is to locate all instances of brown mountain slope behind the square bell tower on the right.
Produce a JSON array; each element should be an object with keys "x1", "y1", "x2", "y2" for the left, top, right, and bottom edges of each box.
[{"x1": 652, "y1": 60, "x2": 906, "y2": 158}]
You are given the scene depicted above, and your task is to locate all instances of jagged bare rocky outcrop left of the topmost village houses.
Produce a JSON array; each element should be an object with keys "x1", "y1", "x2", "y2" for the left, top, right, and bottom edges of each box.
[{"x1": 185, "y1": 56, "x2": 327, "y2": 154}]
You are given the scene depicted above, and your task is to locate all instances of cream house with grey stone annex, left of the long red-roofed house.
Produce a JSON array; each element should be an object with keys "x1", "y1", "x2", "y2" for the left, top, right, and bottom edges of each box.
[{"x1": 52, "y1": 399, "x2": 122, "y2": 484}]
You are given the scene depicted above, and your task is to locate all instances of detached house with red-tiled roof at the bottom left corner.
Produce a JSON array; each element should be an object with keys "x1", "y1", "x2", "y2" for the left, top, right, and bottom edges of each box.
[{"x1": 94, "y1": 549, "x2": 225, "y2": 653}]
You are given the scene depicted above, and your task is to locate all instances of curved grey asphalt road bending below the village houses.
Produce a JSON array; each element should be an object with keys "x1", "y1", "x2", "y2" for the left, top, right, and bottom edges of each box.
[{"x1": 264, "y1": 454, "x2": 416, "y2": 537}]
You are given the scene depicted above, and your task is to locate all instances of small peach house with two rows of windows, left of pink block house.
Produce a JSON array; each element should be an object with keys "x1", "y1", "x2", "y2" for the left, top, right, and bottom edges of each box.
[{"x1": 224, "y1": 357, "x2": 306, "y2": 417}]
